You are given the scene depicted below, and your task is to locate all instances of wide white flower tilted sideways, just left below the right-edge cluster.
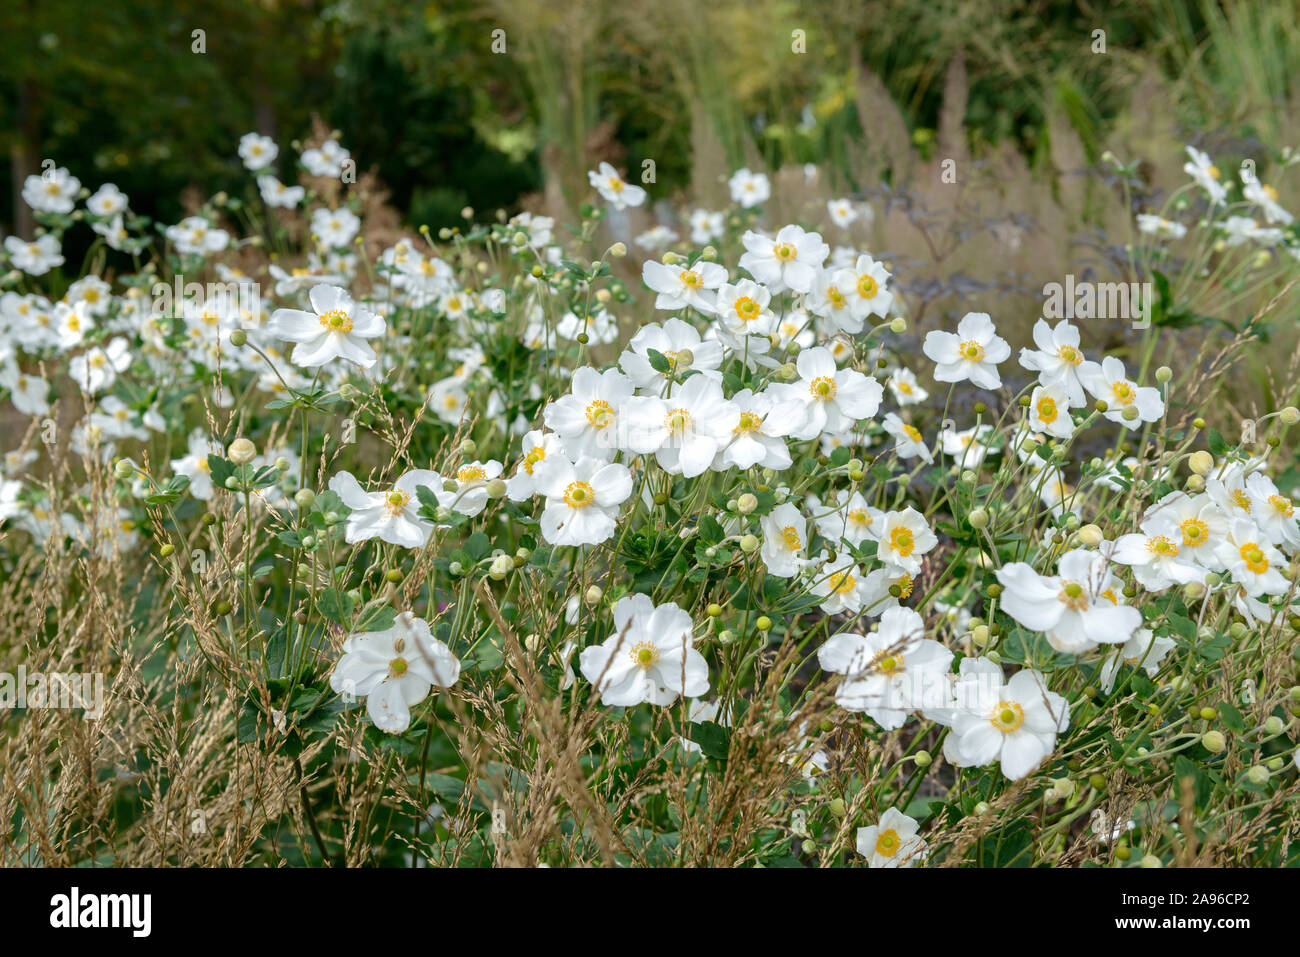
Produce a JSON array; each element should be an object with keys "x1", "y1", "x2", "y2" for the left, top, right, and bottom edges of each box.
[{"x1": 984, "y1": 549, "x2": 1141, "y2": 655}]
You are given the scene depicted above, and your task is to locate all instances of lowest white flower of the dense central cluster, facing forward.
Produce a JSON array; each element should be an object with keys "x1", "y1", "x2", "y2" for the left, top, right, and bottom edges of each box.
[{"x1": 534, "y1": 459, "x2": 632, "y2": 545}]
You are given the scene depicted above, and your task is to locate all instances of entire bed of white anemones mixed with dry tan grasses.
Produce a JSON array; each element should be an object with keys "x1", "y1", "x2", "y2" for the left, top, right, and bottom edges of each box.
[{"x1": 0, "y1": 125, "x2": 1300, "y2": 866}]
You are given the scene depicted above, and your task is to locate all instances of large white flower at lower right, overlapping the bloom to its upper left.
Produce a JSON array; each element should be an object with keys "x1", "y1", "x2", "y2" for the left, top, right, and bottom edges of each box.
[{"x1": 944, "y1": 660, "x2": 1070, "y2": 780}]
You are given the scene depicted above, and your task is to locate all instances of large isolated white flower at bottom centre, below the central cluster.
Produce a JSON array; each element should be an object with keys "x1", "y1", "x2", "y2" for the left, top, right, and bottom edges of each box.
[{"x1": 579, "y1": 594, "x2": 709, "y2": 707}]
